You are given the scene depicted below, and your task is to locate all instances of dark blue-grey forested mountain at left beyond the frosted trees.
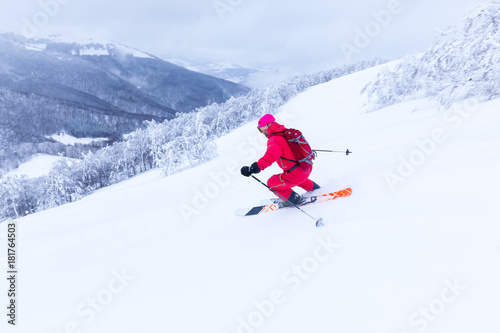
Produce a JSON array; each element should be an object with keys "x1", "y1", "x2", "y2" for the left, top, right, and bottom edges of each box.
[{"x1": 0, "y1": 33, "x2": 250, "y2": 168}]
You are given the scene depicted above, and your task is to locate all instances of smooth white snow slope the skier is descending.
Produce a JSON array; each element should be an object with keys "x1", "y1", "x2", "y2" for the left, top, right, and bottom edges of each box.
[{"x1": 0, "y1": 64, "x2": 500, "y2": 333}]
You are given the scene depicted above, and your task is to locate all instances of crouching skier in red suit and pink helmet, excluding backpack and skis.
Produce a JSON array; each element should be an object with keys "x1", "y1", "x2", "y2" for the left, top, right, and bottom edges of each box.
[{"x1": 241, "y1": 114, "x2": 320, "y2": 206}]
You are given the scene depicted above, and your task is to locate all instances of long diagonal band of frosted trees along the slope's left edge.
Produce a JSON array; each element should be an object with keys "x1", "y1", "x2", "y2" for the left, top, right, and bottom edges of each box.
[{"x1": 0, "y1": 59, "x2": 385, "y2": 220}]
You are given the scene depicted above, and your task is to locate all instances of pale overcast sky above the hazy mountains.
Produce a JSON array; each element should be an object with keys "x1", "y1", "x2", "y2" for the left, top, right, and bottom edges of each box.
[{"x1": 0, "y1": 0, "x2": 485, "y2": 73}]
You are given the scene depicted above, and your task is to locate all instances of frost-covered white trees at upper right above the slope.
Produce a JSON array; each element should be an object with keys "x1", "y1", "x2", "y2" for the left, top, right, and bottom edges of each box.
[{"x1": 363, "y1": 1, "x2": 500, "y2": 110}]
